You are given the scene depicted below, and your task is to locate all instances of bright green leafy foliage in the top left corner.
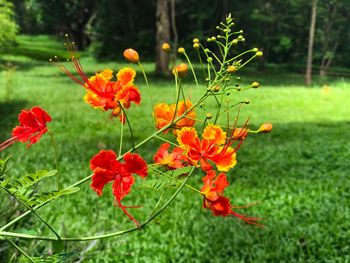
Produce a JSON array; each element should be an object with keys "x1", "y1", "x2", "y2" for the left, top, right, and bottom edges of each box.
[{"x1": 0, "y1": 0, "x2": 18, "y2": 48}]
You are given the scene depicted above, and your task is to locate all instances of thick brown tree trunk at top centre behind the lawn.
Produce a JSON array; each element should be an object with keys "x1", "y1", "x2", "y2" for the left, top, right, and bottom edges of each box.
[{"x1": 156, "y1": 0, "x2": 170, "y2": 75}]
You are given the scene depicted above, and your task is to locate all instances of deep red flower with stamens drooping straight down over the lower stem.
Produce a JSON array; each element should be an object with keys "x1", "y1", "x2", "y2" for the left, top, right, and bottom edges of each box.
[{"x1": 90, "y1": 150, "x2": 147, "y2": 225}]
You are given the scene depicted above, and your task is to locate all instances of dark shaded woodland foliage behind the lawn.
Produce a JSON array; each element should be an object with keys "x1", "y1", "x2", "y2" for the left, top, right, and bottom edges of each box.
[{"x1": 9, "y1": 0, "x2": 350, "y2": 72}]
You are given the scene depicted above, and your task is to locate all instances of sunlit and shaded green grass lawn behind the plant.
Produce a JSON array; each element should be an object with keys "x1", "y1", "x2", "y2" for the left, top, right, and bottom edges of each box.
[{"x1": 0, "y1": 37, "x2": 350, "y2": 262}]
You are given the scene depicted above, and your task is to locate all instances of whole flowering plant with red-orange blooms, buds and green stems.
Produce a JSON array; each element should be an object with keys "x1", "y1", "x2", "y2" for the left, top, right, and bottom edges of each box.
[{"x1": 0, "y1": 15, "x2": 272, "y2": 260}]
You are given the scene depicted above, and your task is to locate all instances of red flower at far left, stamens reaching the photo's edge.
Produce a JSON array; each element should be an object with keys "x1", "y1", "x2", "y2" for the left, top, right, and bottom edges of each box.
[{"x1": 0, "y1": 107, "x2": 51, "y2": 151}]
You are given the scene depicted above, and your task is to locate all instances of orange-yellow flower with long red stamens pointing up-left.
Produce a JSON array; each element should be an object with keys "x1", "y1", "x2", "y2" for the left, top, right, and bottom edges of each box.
[{"x1": 56, "y1": 36, "x2": 141, "y2": 123}]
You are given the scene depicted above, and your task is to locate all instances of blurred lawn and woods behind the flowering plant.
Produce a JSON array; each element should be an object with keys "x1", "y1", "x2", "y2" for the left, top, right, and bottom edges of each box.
[{"x1": 0, "y1": 0, "x2": 350, "y2": 263}]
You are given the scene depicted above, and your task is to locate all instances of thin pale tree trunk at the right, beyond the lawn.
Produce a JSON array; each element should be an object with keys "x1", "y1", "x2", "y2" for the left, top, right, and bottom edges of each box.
[{"x1": 305, "y1": 0, "x2": 317, "y2": 85}]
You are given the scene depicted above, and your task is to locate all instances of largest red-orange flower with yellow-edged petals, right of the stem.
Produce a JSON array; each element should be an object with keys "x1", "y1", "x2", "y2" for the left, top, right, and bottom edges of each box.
[{"x1": 177, "y1": 124, "x2": 242, "y2": 172}]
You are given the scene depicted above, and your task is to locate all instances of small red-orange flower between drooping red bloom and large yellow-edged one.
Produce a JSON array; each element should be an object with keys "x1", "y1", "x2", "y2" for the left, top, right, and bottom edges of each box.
[{"x1": 153, "y1": 143, "x2": 187, "y2": 169}]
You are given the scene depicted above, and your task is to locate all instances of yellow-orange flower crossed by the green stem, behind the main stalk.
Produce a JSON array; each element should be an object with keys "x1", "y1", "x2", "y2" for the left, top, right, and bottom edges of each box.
[{"x1": 154, "y1": 100, "x2": 196, "y2": 133}]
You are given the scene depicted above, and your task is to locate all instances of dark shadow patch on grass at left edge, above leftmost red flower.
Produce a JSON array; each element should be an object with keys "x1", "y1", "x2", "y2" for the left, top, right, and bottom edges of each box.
[{"x1": 0, "y1": 100, "x2": 27, "y2": 140}]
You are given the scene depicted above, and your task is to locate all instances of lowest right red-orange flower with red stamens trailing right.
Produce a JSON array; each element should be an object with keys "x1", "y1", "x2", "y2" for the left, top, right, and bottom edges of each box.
[{"x1": 201, "y1": 171, "x2": 262, "y2": 226}]
